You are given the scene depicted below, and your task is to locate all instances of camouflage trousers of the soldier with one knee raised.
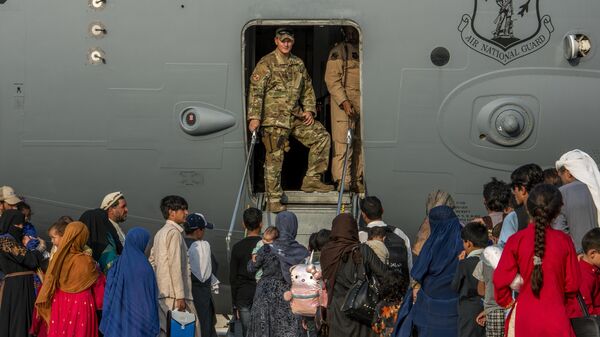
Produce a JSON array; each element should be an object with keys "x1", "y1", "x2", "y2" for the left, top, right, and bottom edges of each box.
[{"x1": 262, "y1": 119, "x2": 331, "y2": 201}]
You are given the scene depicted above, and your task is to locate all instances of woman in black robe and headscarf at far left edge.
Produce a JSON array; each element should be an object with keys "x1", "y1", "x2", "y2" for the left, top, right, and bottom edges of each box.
[{"x1": 0, "y1": 210, "x2": 46, "y2": 337}]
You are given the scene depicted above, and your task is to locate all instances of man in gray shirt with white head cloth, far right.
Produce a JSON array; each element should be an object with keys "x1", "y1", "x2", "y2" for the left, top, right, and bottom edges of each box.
[{"x1": 553, "y1": 150, "x2": 600, "y2": 253}]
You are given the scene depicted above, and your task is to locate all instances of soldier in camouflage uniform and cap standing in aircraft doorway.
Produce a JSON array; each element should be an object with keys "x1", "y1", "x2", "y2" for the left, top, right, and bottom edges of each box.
[{"x1": 248, "y1": 28, "x2": 333, "y2": 212}]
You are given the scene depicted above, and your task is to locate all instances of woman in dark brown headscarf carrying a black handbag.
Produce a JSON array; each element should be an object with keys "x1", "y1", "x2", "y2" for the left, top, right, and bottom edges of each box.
[{"x1": 321, "y1": 213, "x2": 387, "y2": 337}]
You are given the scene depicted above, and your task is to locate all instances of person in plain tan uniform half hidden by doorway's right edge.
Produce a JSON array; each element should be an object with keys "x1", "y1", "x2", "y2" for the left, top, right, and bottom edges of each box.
[{"x1": 325, "y1": 27, "x2": 364, "y2": 192}]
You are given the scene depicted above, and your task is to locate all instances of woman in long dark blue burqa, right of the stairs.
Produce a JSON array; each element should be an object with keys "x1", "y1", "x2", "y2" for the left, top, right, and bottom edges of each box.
[{"x1": 394, "y1": 206, "x2": 463, "y2": 337}]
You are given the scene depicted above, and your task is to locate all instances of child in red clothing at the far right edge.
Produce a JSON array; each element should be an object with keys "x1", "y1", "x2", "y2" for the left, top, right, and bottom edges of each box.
[{"x1": 569, "y1": 228, "x2": 600, "y2": 317}]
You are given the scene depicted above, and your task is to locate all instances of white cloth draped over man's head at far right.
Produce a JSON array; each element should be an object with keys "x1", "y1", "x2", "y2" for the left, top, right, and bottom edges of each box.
[{"x1": 556, "y1": 150, "x2": 600, "y2": 221}]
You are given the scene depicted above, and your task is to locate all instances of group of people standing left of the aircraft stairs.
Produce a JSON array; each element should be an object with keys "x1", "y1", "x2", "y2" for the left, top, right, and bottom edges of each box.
[{"x1": 0, "y1": 192, "x2": 220, "y2": 337}]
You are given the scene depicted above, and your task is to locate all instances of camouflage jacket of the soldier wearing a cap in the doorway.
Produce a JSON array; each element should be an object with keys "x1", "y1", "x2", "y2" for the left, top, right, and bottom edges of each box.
[{"x1": 248, "y1": 49, "x2": 316, "y2": 129}]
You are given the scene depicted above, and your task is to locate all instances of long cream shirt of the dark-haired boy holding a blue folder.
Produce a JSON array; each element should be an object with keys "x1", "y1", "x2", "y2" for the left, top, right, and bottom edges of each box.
[{"x1": 149, "y1": 220, "x2": 193, "y2": 300}]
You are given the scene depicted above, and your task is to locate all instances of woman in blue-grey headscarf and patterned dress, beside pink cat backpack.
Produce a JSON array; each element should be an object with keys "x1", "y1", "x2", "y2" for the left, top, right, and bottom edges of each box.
[{"x1": 248, "y1": 211, "x2": 308, "y2": 337}]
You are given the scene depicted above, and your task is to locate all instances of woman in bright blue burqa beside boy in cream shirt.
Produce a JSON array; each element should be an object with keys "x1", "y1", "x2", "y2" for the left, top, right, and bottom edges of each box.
[{"x1": 100, "y1": 228, "x2": 160, "y2": 337}]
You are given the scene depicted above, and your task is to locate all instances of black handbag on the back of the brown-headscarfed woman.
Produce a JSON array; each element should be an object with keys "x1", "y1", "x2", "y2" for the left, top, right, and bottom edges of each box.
[{"x1": 341, "y1": 247, "x2": 379, "y2": 326}]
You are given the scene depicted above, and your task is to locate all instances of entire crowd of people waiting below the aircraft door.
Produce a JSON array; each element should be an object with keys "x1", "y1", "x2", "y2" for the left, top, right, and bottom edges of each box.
[{"x1": 0, "y1": 150, "x2": 600, "y2": 337}]
